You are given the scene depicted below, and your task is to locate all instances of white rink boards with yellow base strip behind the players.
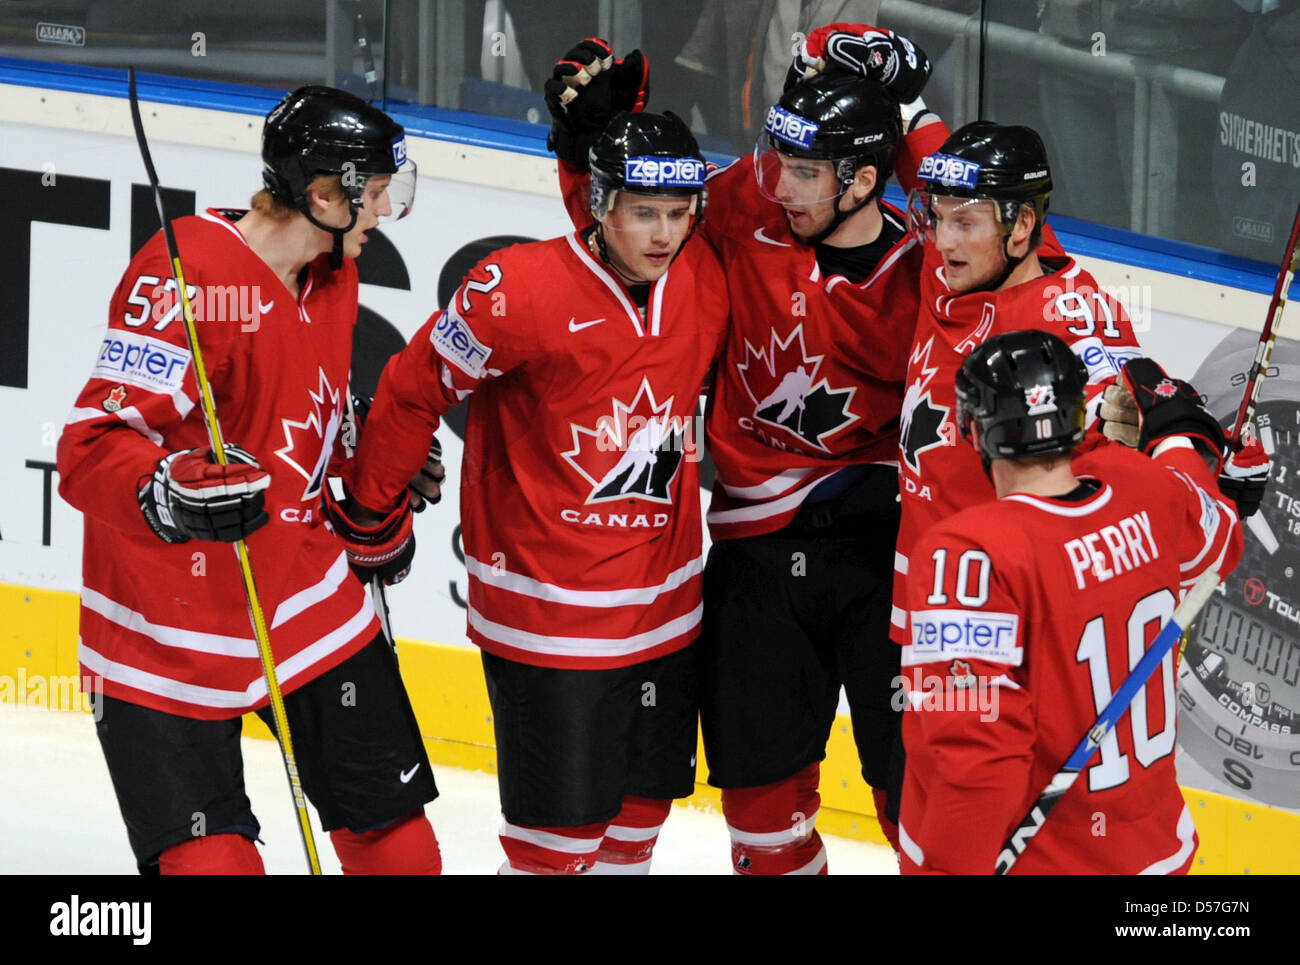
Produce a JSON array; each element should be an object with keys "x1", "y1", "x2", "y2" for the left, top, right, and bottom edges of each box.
[{"x1": 0, "y1": 72, "x2": 1300, "y2": 874}]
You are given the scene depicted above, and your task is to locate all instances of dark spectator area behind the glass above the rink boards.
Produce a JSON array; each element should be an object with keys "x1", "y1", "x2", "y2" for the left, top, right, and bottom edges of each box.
[{"x1": 0, "y1": 0, "x2": 1300, "y2": 263}]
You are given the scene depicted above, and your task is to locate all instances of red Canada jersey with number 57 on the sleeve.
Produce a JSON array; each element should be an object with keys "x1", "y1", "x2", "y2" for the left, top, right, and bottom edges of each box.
[{"x1": 59, "y1": 211, "x2": 380, "y2": 719}]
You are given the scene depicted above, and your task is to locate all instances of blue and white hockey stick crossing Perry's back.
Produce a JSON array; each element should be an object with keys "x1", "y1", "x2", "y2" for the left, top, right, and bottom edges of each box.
[{"x1": 995, "y1": 570, "x2": 1219, "y2": 874}]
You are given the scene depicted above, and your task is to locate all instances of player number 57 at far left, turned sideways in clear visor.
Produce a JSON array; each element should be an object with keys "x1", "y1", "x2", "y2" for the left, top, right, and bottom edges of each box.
[{"x1": 59, "y1": 87, "x2": 441, "y2": 874}]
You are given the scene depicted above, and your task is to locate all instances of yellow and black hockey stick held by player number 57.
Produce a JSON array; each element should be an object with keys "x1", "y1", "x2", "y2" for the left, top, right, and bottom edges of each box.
[{"x1": 127, "y1": 66, "x2": 321, "y2": 874}]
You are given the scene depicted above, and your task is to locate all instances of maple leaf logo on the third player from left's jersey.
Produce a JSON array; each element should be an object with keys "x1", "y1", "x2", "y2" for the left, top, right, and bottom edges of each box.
[{"x1": 736, "y1": 325, "x2": 858, "y2": 453}]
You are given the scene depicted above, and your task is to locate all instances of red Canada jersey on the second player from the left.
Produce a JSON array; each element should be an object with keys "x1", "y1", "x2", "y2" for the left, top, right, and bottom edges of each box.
[{"x1": 352, "y1": 234, "x2": 728, "y2": 668}]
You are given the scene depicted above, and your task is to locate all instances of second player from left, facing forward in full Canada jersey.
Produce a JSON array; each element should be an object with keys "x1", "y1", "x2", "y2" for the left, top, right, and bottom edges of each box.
[{"x1": 351, "y1": 113, "x2": 728, "y2": 874}]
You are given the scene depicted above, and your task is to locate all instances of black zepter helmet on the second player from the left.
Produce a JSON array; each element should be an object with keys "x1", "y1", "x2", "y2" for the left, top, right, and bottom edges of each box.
[{"x1": 588, "y1": 111, "x2": 706, "y2": 221}]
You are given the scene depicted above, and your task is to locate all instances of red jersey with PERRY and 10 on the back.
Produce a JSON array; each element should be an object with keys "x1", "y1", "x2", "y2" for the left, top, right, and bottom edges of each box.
[{"x1": 900, "y1": 445, "x2": 1242, "y2": 874}]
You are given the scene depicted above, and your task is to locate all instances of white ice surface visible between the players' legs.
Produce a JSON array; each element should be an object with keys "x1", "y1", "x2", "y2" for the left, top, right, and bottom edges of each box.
[{"x1": 0, "y1": 705, "x2": 898, "y2": 875}]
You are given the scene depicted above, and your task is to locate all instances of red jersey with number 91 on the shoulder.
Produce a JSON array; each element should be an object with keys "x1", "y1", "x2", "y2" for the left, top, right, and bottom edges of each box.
[{"x1": 891, "y1": 243, "x2": 1143, "y2": 644}]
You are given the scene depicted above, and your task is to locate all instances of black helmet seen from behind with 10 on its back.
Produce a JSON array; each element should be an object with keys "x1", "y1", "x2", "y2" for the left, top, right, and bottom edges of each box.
[{"x1": 954, "y1": 329, "x2": 1088, "y2": 469}]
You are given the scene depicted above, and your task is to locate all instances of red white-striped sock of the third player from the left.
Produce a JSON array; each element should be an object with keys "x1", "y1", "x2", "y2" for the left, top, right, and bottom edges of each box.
[{"x1": 723, "y1": 763, "x2": 827, "y2": 874}]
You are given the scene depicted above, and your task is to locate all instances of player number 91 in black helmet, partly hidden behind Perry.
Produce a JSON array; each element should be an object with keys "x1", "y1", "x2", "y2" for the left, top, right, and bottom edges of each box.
[{"x1": 892, "y1": 121, "x2": 1141, "y2": 644}]
